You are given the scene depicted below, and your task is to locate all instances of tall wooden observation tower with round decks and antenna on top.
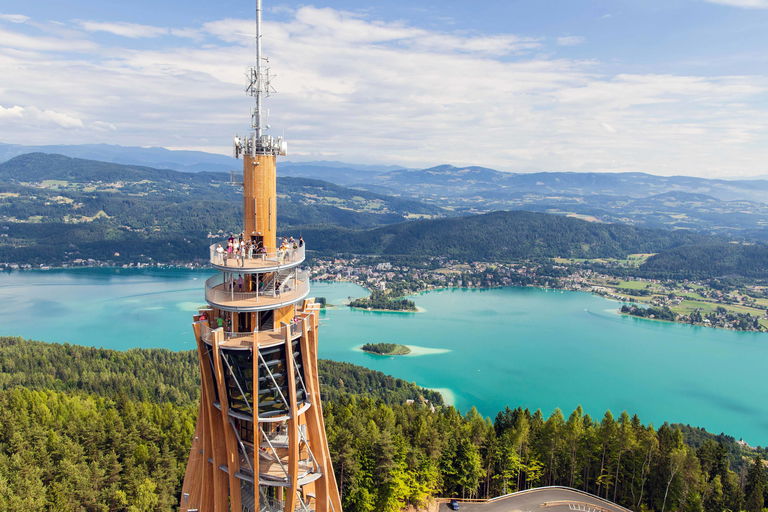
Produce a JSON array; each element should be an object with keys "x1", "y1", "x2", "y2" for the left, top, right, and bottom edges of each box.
[{"x1": 180, "y1": 0, "x2": 342, "y2": 512}]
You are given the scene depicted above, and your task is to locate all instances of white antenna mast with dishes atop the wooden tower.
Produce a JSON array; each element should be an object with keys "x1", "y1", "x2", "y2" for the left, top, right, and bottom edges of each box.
[{"x1": 234, "y1": 0, "x2": 288, "y2": 158}]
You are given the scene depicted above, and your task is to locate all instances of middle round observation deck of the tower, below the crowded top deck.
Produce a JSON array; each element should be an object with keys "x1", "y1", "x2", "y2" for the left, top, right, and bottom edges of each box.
[{"x1": 205, "y1": 269, "x2": 309, "y2": 313}]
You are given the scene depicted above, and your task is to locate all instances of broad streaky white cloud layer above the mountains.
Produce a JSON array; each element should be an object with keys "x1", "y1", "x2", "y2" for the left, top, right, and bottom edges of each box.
[{"x1": 0, "y1": 7, "x2": 768, "y2": 176}]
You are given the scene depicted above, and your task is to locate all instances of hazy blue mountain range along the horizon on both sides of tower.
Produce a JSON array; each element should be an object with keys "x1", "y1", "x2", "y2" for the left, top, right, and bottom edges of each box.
[{"x1": 0, "y1": 144, "x2": 768, "y2": 240}]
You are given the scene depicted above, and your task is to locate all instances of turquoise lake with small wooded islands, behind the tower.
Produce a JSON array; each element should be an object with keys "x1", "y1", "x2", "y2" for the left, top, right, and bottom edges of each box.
[{"x1": 0, "y1": 269, "x2": 768, "y2": 445}]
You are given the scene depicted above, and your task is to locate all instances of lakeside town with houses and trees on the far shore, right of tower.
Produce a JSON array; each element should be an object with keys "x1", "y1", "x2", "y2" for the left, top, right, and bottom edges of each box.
[{"x1": 309, "y1": 257, "x2": 768, "y2": 332}]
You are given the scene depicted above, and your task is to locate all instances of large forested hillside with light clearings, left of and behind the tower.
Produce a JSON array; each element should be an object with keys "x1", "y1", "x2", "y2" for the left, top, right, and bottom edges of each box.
[{"x1": 0, "y1": 153, "x2": 442, "y2": 264}]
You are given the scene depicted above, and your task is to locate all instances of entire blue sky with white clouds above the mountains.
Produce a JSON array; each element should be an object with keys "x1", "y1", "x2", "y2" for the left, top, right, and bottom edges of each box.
[{"x1": 0, "y1": 0, "x2": 768, "y2": 178}]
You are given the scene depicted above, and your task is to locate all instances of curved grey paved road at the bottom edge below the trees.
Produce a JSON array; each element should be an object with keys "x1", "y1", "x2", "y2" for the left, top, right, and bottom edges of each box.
[{"x1": 439, "y1": 488, "x2": 627, "y2": 512}]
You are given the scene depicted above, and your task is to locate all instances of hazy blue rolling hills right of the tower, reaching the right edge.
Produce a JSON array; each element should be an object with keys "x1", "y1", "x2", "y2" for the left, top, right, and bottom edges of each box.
[{"x1": 294, "y1": 165, "x2": 768, "y2": 241}]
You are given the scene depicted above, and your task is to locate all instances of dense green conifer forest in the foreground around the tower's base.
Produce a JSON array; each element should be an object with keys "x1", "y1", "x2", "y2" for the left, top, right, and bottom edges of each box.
[{"x1": 0, "y1": 338, "x2": 768, "y2": 512}]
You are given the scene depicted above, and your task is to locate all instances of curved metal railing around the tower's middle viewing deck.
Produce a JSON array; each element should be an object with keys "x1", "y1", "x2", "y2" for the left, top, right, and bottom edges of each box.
[{"x1": 205, "y1": 271, "x2": 309, "y2": 307}]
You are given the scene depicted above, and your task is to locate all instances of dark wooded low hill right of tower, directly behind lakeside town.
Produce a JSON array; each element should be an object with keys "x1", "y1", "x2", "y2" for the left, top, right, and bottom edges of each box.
[{"x1": 304, "y1": 211, "x2": 708, "y2": 261}]
